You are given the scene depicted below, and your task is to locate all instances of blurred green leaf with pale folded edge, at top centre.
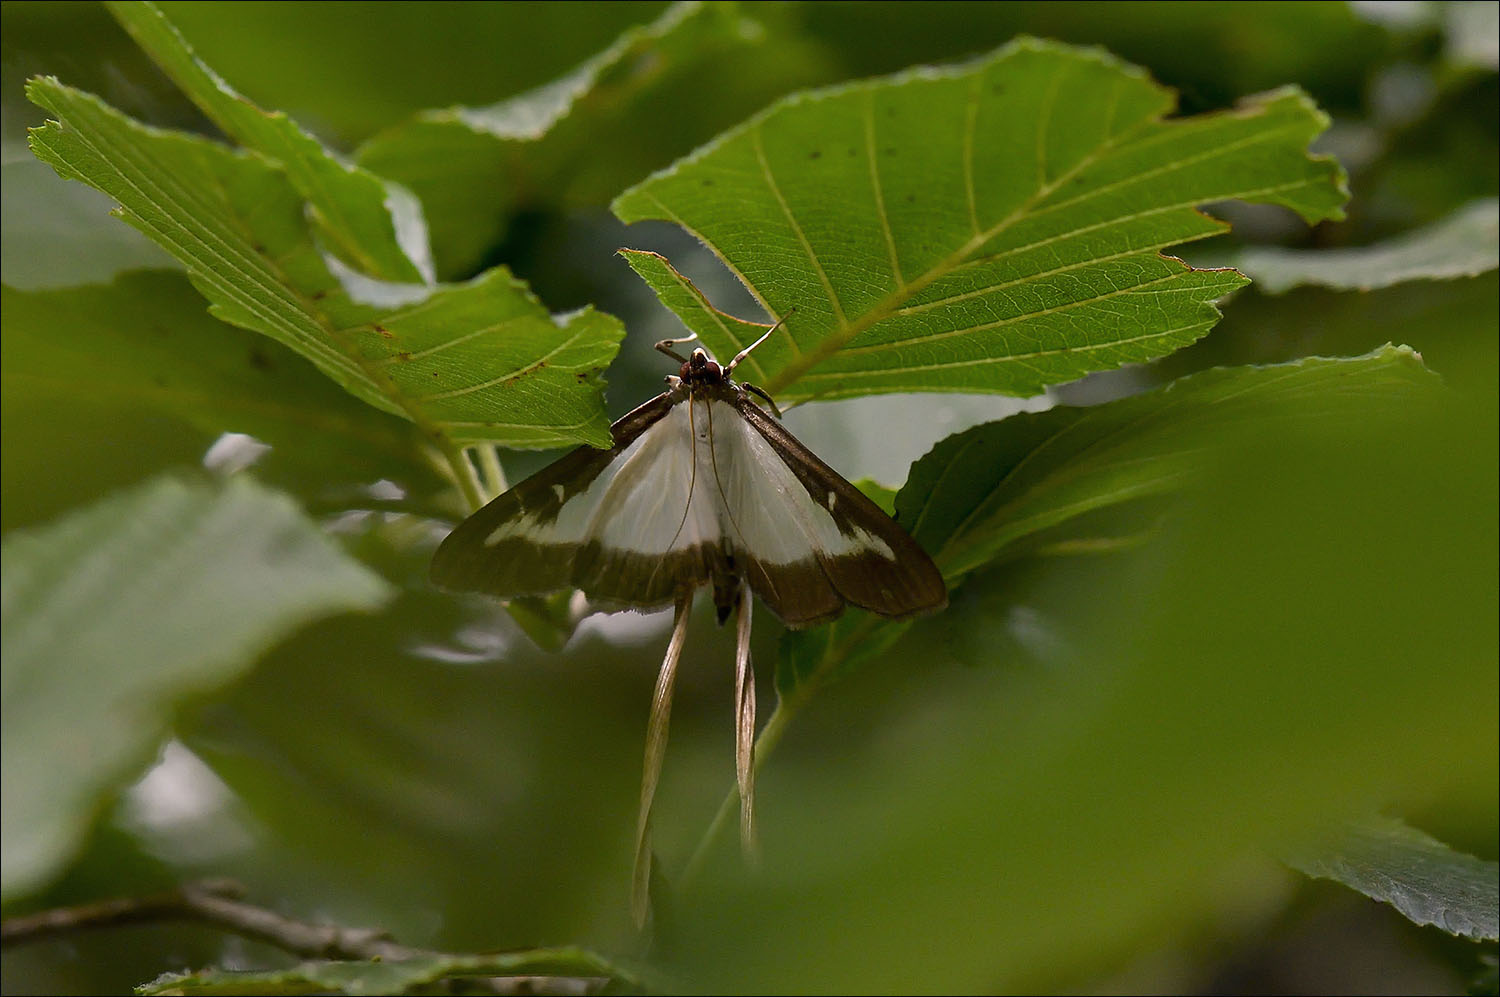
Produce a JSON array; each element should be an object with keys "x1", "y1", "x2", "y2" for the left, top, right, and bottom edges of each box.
[{"x1": 359, "y1": 3, "x2": 804, "y2": 280}]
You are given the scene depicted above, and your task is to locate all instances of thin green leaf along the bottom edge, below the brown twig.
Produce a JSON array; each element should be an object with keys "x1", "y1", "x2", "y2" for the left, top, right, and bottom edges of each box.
[{"x1": 135, "y1": 948, "x2": 642, "y2": 996}]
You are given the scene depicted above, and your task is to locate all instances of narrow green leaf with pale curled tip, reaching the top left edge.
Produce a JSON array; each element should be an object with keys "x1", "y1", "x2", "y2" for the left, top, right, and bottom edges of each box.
[{"x1": 107, "y1": 0, "x2": 432, "y2": 283}]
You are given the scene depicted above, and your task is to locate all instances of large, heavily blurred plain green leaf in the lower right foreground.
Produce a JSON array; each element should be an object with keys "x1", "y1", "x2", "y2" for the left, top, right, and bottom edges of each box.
[{"x1": 674, "y1": 338, "x2": 1500, "y2": 993}]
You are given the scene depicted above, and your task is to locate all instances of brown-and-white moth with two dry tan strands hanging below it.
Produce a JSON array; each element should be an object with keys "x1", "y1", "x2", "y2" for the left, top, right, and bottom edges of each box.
[{"x1": 432, "y1": 322, "x2": 948, "y2": 922}]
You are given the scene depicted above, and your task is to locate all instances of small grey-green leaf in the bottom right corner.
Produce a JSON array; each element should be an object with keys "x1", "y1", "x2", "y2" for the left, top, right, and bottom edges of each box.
[{"x1": 1290, "y1": 819, "x2": 1500, "y2": 942}]
